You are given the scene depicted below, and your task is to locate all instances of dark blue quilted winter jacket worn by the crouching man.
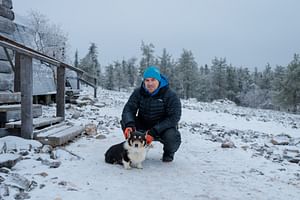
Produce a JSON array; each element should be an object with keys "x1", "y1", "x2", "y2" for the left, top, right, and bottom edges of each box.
[{"x1": 122, "y1": 75, "x2": 181, "y2": 137}]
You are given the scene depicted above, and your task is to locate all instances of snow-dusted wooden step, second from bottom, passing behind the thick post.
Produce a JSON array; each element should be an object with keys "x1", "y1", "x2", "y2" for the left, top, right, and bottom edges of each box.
[{"x1": 5, "y1": 117, "x2": 63, "y2": 129}]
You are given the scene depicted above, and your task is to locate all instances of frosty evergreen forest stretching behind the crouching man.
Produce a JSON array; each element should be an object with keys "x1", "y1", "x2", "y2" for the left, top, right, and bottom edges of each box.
[{"x1": 74, "y1": 41, "x2": 300, "y2": 113}]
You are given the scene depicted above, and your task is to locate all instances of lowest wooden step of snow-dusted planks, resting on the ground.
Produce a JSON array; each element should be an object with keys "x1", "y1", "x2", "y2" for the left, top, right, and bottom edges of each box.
[{"x1": 34, "y1": 124, "x2": 85, "y2": 147}]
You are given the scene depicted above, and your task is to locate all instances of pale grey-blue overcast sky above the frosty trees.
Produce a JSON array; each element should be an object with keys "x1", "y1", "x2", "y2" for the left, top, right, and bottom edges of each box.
[{"x1": 13, "y1": 0, "x2": 300, "y2": 68}]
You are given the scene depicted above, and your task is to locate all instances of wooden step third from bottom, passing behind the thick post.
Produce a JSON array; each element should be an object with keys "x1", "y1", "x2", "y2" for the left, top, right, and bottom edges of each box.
[{"x1": 0, "y1": 104, "x2": 42, "y2": 123}]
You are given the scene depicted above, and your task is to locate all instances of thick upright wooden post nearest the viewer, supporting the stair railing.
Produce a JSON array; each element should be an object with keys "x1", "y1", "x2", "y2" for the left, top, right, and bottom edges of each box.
[{"x1": 16, "y1": 54, "x2": 33, "y2": 139}]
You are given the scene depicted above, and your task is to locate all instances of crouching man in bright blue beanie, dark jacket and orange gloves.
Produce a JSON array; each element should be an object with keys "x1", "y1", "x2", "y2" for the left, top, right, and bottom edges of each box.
[{"x1": 121, "y1": 66, "x2": 181, "y2": 162}]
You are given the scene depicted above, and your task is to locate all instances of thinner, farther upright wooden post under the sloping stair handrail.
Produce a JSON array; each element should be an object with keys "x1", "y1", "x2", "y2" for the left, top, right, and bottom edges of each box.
[{"x1": 56, "y1": 66, "x2": 66, "y2": 119}]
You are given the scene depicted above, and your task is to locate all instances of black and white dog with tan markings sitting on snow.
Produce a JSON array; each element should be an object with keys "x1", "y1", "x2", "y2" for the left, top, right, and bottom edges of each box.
[{"x1": 105, "y1": 131, "x2": 148, "y2": 169}]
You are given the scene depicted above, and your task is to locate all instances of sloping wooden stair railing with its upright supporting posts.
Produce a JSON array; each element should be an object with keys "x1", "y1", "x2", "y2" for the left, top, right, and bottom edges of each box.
[{"x1": 0, "y1": 35, "x2": 97, "y2": 139}]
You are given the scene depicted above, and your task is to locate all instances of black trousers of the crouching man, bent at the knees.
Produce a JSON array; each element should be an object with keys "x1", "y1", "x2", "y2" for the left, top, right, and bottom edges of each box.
[{"x1": 121, "y1": 121, "x2": 181, "y2": 154}]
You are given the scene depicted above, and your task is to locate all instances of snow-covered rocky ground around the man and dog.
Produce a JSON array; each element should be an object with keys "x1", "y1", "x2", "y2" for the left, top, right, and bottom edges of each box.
[{"x1": 0, "y1": 86, "x2": 300, "y2": 200}]
